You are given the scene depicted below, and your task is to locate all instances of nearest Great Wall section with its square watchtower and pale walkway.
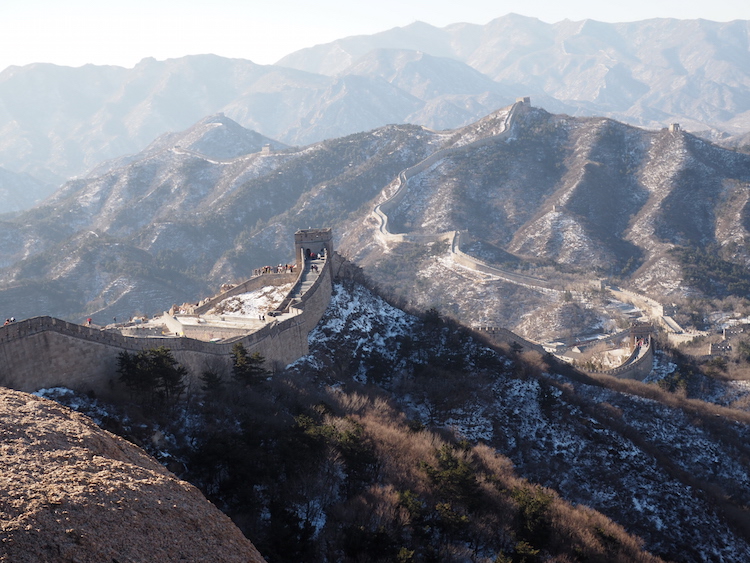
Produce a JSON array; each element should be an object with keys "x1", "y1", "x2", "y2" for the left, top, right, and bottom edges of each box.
[{"x1": 0, "y1": 229, "x2": 342, "y2": 396}]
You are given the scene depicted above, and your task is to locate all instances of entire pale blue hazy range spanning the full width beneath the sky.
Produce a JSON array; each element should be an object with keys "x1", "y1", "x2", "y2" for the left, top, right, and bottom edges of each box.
[{"x1": 0, "y1": 15, "x2": 750, "y2": 193}]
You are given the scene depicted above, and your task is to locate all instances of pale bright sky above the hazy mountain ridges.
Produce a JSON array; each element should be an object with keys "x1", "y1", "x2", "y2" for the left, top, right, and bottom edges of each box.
[{"x1": 0, "y1": 0, "x2": 750, "y2": 70}]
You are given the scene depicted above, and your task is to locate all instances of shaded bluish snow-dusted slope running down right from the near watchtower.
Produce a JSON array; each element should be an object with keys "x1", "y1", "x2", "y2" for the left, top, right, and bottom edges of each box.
[{"x1": 290, "y1": 284, "x2": 750, "y2": 562}]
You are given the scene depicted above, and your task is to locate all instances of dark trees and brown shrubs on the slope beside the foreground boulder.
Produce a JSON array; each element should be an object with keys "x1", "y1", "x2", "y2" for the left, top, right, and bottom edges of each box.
[{"x1": 125, "y1": 354, "x2": 659, "y2": 563}]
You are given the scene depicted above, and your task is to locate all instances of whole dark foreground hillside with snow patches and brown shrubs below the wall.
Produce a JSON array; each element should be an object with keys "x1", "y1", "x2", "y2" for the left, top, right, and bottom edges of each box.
[{"x1": 39, "y1": 280, "x2": 750, "y2": 563}]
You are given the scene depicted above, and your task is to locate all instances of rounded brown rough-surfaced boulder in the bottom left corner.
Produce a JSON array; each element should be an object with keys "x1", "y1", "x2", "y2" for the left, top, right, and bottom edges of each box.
[{"x1": 0, "y1": 389, "x2": 263, "y2": 563}]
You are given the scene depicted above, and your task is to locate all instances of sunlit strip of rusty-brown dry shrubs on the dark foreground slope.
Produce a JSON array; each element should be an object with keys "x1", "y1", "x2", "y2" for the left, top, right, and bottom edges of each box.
[{"x1": 322, "y1": 393, "x2": 658, "y2": 562}]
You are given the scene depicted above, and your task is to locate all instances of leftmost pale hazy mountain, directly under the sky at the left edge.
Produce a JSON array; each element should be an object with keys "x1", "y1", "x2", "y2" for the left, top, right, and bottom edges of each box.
[{"x1": 0, "y1": 55, "x2": 324, "y2": 182}]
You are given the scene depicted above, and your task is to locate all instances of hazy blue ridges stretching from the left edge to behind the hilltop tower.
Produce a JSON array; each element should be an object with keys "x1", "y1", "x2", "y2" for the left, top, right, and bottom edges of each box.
[{"x1": 0, "y1": 55, "x2": 512, "y2": 187}]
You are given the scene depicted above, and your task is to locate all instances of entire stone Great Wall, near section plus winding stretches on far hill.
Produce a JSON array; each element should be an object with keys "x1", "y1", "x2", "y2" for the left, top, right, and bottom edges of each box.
[{"x1": 0, "y1": 98, "x2": 658, "y2": 396}]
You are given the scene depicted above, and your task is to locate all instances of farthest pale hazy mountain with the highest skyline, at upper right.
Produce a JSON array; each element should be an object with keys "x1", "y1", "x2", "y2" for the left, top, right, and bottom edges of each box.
[{"x1": 277, "y1": 14, "x2": 750, "y2": 131}]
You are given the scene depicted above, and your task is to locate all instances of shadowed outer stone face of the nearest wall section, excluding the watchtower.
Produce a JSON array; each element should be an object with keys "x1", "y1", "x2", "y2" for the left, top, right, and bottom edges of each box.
[{"x1": 0, "y1": 254, "x2": 339, "y2": 396}]
